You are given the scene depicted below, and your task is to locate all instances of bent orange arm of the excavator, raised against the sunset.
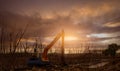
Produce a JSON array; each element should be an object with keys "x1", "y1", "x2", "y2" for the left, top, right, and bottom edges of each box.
[{"x1": 42, "y1": 31, "x2": 64, "y2": 61}]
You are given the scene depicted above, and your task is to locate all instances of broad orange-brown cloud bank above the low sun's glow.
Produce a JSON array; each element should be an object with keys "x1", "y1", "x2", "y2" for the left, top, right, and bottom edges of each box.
[{"x1": 0, "y1": 0, "x2": 120, "y2": 44}]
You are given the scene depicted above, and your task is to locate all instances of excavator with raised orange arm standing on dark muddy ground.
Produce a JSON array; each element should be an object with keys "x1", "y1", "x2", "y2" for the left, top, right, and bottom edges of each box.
[{"x1": 27, "y1": 30, "x2": 65, "y2": 67}]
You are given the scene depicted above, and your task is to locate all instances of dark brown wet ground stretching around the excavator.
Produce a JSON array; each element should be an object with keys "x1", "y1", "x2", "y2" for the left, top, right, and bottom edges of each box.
[{"x1": 0, "y1": 54, "x2": 120, "y2": 71}]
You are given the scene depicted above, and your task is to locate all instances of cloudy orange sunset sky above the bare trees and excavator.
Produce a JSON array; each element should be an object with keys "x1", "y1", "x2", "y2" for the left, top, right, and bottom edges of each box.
[{"x1": 0, "y1": 0, "x2": 120, "y2": 44}]
